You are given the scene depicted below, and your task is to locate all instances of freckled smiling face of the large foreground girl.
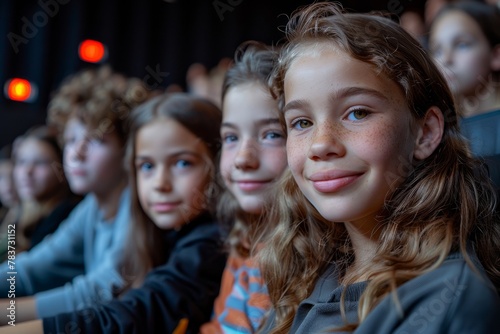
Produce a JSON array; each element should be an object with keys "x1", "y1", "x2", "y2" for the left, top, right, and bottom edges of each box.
[{"x1": 284, "y1": 46, "x2": 416, "y2": 226}]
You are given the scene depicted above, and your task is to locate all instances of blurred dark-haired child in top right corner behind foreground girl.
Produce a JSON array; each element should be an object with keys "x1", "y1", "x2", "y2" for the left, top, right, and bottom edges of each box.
[{"x1": 430, "y1": 1, "x2": 500, "y2": 156}]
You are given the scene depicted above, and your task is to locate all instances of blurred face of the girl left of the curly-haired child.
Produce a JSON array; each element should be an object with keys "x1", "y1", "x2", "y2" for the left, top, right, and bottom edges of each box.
[{"x1": 14, "y1": 138, "x2": 65, "y2": 201}]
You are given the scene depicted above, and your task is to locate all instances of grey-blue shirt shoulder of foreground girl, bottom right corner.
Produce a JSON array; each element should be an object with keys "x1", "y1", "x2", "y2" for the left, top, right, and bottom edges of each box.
[{"x1": 358, "y1": 254, "x2": 500, "y2": 334}]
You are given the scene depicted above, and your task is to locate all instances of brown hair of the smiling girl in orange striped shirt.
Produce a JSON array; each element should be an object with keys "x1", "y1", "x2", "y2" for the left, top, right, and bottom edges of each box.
[{"x1": 217, "y1": 41, "x2": 278, "y2": 258}]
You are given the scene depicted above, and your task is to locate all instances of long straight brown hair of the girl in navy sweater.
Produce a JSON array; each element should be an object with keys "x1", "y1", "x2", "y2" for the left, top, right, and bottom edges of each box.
[{"x1": 121, "y1": 93, "x2": 222, "y2": 292}]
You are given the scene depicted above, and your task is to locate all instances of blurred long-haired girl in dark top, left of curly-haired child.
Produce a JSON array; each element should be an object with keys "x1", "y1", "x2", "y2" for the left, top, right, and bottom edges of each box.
[{"x1": 13, "y1": 126, "x2": 78, "y2": 250}]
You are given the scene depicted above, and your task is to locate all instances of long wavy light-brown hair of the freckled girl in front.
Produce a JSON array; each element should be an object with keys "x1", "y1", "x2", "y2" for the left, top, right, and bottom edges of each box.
[{"x1": 258, "y1": 3, "x2": 500, "y2": 333}]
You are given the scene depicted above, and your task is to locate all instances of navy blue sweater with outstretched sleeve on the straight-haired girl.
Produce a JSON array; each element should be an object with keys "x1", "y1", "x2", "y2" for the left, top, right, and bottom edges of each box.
[{"x1": 43, "y1": 216, "x2": 226, "y2": 333}]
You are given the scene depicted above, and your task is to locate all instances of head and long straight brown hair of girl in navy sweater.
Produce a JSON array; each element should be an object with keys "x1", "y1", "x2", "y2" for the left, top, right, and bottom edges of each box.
[{"x1": 118, "y1": 93, "x2": 222, "y2": 287}]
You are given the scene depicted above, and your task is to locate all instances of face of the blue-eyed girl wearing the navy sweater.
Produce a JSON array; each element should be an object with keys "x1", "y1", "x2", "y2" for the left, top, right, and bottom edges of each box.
[{"x1": 135, "y1": 118, "x2": 212, "y2": 230}]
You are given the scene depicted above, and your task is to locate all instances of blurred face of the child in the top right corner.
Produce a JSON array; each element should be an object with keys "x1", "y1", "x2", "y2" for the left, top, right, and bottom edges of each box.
[{"x1": 429, "y1": 10, "x2": 493, "y2": 97}]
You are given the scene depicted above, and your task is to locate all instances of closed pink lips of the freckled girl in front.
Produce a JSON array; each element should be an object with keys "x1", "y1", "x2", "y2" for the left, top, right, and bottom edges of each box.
[{"x1": 309, "y1": 170, "x2": 363, "y2": 193}]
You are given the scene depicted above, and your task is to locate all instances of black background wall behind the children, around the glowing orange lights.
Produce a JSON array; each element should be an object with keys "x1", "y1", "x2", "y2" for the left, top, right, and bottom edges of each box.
[{"x1": 0, "y1": 0, "x2": 423, "y2": 146}]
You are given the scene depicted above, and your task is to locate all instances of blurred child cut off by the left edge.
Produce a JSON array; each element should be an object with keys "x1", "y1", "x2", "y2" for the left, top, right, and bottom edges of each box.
[{"x1": 0, "y1": 144, "x2": 20, "y2": 262}]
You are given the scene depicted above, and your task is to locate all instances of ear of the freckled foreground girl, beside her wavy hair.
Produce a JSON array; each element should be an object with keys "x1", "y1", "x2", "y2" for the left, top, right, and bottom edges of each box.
[{"x1": 413, "y1": 106, "x2": 444, "y2": 160}]
